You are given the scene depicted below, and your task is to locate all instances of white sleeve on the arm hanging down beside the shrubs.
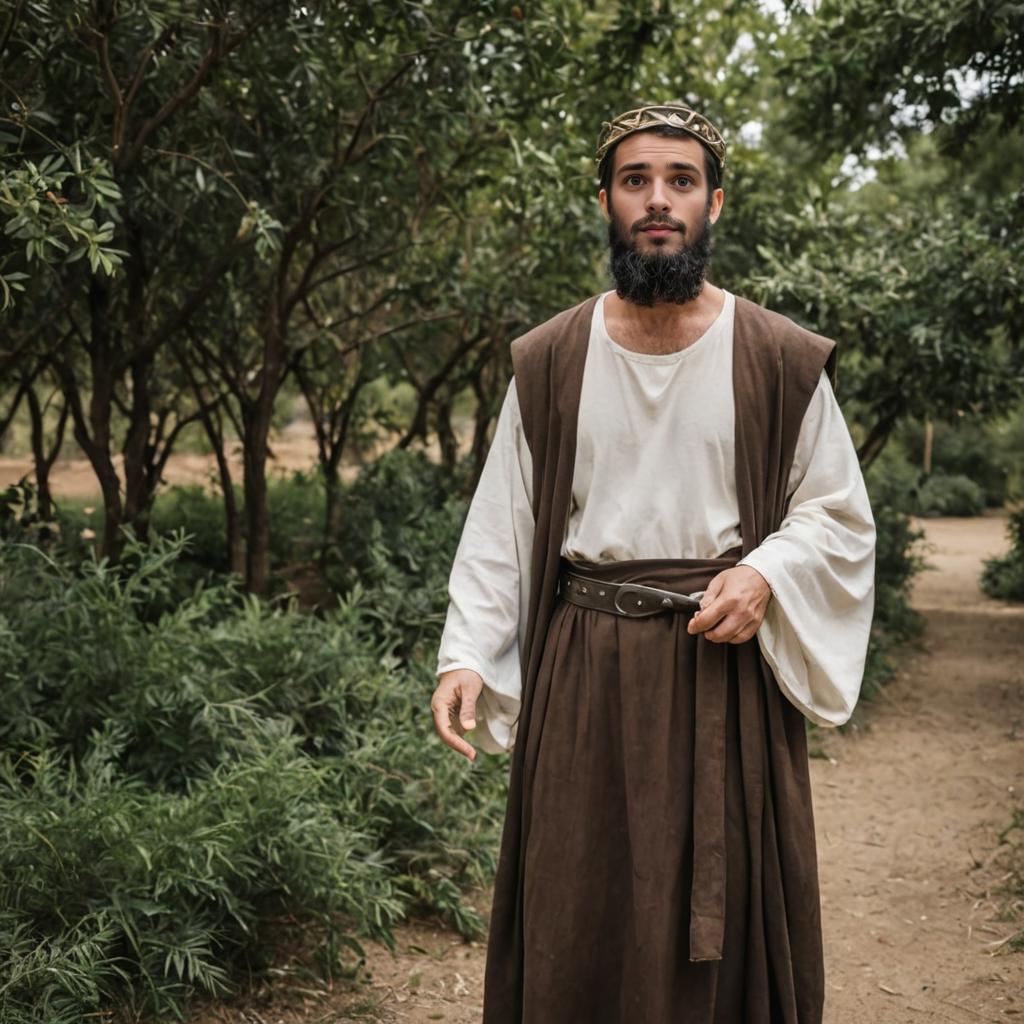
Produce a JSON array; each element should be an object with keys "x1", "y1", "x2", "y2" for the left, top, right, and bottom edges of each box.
[{"x1": 437, "y1": 379, "x2": 534, "y2": 754}]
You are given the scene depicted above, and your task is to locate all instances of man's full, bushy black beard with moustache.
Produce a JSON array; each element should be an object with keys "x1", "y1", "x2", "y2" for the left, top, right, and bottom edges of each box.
[{"x1": 608, "y1": 204, "x2": 714, "y2": 306}]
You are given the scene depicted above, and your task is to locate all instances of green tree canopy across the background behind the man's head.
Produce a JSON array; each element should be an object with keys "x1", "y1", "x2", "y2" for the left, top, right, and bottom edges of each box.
[{"x1": 0, "y1": 0, "x2": 1024, "y2": 592}]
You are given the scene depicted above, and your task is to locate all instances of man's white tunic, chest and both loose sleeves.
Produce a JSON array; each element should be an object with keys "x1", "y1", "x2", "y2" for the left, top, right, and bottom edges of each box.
[{"x1": 437, "y1": 292, "x2": 874, "y2": 753}]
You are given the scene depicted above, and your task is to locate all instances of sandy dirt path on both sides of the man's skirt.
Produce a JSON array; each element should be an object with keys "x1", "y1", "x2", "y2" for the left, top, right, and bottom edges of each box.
[{"x1": 195, "y1": 517, "x2": 1024, "y2": 1024}]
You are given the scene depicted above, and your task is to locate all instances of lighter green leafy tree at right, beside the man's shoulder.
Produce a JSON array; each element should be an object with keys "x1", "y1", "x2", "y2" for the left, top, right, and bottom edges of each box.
[{"x1": 754, "y1": 186, "x2": 1024, "y2": 465}]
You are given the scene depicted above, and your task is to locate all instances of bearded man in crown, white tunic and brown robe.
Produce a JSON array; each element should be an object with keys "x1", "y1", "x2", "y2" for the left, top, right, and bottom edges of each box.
[{"x1": 432, "y1": 103, "x2": 874, "y2": 1024}]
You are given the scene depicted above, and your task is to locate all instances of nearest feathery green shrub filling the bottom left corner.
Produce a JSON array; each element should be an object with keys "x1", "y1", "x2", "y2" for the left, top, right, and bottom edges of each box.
[{"x1": 0, "y1": 724, "x2": 389, "y2": 1021}]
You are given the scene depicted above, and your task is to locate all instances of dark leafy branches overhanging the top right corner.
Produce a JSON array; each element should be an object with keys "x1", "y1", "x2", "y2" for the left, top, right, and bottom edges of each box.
[{"x1": 781, "y1": 0, "x2": 1024, "y2": 150}]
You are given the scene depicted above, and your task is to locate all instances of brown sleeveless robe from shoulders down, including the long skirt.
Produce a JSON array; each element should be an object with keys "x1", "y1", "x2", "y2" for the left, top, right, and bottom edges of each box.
[{"x1": 483, "y1": 296, "x2": 835, "y2": 1024}]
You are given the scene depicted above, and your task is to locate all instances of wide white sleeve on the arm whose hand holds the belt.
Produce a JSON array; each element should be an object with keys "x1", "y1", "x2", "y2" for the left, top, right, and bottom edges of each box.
[{"x1": 741, "y1": 374, "x2": 874, "y2": 726}]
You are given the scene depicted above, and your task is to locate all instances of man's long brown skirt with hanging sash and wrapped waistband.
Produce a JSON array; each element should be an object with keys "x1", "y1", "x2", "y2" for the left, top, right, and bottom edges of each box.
[{"x1": 483, "y1": 552, "x2": 823, "y2": 1024}]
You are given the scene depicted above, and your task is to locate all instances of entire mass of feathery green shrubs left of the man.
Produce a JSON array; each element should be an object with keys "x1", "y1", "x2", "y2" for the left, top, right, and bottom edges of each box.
[{"x1": 0, "y1": 538, "x2": 506, "y2": 1024}]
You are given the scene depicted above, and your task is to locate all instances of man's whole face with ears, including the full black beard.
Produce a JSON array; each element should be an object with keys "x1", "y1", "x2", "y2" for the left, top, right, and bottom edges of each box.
[{"x1": 598, "y1": 132, "x2": 723, "y2": 306}]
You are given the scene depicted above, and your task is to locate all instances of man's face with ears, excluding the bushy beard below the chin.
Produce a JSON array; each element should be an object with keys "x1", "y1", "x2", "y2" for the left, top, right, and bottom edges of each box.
[{"x1": 598, "y1": 132, "x2": 724, "y2": 248}]
